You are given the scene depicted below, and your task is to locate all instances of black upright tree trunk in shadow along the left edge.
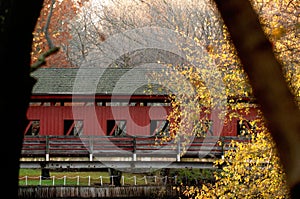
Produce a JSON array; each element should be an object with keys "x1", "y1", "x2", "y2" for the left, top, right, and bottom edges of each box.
[{"x1": 0, "y1": 0, "x2": 43, "y2": 198}]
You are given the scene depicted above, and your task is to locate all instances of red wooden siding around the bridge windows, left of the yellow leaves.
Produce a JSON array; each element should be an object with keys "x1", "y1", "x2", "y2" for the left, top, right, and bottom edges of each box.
[{"x1": 27, "y1": 106, "x2": 168, "y2": 135}]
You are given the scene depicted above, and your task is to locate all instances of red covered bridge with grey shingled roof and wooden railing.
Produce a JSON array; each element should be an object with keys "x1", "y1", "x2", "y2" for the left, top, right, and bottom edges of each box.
[{"x1": 21, "y1": 68, "x2": 257, "y2": 167}]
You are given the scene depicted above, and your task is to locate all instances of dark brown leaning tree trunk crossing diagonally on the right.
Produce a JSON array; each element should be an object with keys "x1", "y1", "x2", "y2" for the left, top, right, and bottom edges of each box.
[{"x1": 215, "y1": 0, "x2": 300, "y2": 198}]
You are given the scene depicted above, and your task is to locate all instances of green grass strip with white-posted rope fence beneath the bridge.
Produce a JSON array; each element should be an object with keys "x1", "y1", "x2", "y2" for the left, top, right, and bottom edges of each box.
[{"x1": 19, "y1": 168, "x2": 212, "y2": 186}]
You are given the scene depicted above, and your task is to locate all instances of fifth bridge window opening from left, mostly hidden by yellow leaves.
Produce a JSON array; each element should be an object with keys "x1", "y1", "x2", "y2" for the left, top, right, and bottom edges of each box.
[{"x1": 194, "y1": 120, "x2": 214, "y2": 137}]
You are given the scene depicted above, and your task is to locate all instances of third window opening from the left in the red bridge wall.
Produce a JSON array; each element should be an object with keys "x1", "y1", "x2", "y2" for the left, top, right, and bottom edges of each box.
[{"x1": 106, "y1": 120, "x2": 126, "y2": 136}]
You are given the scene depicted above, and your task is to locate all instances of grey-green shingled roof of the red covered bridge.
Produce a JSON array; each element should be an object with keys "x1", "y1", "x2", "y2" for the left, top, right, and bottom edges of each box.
[{"x1": 31, "y1": 67, "x2": 167, "y2": 95}]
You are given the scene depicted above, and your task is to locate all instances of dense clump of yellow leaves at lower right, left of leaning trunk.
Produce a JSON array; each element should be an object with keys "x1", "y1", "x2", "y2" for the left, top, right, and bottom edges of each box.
[{"x1": 183, "y1": 131, "x2": 290, "y2": 199}]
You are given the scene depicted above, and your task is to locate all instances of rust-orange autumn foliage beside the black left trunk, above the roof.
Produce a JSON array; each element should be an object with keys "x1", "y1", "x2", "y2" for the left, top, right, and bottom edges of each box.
[{"x1": 31, "y1": 0, "x2": 86, "y2": 67}]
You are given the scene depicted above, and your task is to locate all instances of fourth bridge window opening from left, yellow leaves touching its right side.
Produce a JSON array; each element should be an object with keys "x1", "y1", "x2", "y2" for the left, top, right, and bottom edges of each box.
[{"x1": 150, "y1": 120, "x2": 170, "y2": 136}]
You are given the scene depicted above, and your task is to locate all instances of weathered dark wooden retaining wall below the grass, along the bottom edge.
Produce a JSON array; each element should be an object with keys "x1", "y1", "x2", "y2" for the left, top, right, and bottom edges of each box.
[{"x1": 18, "y1": 186, "x2": 178, "y2": 199}]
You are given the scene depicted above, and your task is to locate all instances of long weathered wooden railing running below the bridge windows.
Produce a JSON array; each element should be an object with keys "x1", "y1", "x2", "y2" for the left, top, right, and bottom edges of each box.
[{"x1": 22, "y1": 136, "x2": 250, "y2": 161}]
